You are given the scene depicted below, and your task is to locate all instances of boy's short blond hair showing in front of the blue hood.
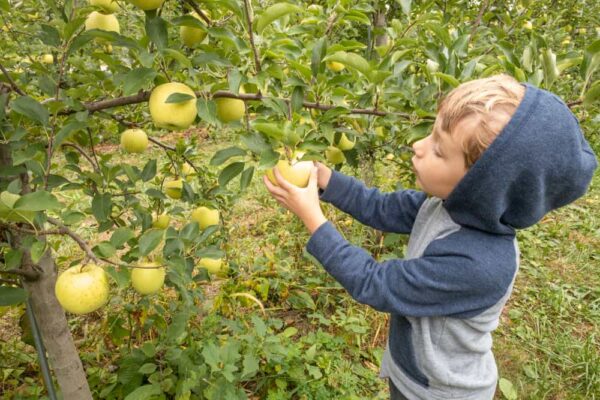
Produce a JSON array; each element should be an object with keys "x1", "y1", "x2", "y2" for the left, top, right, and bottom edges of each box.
[{"x1": 433, "y1": 74, "x2": 525, "y2": 168}]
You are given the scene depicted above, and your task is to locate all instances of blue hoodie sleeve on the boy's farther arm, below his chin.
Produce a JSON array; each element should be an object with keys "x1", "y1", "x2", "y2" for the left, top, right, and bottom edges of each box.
[{"x1": 321, "y1": 171, "x2": 427, "y2": 233}]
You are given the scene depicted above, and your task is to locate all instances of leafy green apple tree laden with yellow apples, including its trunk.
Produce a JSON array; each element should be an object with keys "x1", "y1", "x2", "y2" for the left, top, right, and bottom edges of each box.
[{"x1": 0, "y1": 0, "x2": 600, "y2": 399}]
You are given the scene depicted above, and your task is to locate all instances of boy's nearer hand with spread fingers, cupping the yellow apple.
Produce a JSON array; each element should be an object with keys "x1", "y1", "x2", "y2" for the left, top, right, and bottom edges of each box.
[{"x1": 263, "y1": 162, "x2": 327, "y2": 233}]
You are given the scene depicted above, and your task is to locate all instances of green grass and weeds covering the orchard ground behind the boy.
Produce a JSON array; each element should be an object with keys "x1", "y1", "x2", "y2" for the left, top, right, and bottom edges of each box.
[{"x1": 0, "y1": 124, "x2": 600, "y2": 400}]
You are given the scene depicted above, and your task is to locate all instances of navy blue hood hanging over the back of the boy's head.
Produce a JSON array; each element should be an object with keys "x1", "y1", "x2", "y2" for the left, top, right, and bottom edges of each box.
[{"x1": 444, "y1": 84, "x2": 598, "y2": 234}]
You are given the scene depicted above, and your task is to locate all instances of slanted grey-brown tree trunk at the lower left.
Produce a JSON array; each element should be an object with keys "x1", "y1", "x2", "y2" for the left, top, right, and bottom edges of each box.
[{"x1": 0, "y1": 144, "x2": 92, "y2": 400}]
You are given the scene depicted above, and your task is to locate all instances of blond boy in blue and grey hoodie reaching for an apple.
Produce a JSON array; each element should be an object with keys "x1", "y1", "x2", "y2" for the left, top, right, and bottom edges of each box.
[{"x1": 264, "y1": 75, "x2": 597, "y2": 400}]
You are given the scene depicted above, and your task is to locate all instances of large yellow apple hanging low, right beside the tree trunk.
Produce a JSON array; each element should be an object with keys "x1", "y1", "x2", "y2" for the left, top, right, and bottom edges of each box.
[{"x1": 54, "y1": 264, "x2": 109, "y2": 314}]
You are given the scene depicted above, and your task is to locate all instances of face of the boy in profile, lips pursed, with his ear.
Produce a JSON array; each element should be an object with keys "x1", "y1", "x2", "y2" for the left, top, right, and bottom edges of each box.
[{"x1": 412, "y1": 117, "x2": 477, "y2": 199}]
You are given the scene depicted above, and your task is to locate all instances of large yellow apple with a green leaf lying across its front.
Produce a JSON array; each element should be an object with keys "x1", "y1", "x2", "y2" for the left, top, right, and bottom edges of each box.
[{"x1": 150, "y1": 82, "x2": 198, "y2": 130}]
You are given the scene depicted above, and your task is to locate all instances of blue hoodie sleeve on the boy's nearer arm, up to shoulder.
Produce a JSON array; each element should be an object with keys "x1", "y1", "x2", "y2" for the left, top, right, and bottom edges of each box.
[{"x1": 307, "y1": 222, "x2": 517, "y2": 318}]
